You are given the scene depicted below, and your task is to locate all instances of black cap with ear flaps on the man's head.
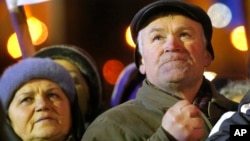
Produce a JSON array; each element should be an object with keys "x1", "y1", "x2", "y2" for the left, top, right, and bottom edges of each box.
[{"x1": 130, "y1": 0, "x2": 214, "y2": 67}]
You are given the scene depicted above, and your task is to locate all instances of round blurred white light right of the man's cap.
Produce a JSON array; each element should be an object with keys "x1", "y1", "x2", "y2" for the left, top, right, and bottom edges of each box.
[{"x1": 207, "y1": 3, "x2": 232, "y2": 28}]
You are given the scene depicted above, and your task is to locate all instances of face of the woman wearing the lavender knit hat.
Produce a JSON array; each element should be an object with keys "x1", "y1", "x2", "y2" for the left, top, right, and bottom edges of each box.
[{"x1": 8, "y1": 79, "x2": 71, "y2": 140}]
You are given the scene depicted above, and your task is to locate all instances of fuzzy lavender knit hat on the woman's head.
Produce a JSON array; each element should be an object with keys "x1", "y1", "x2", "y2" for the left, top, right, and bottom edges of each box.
[{"x1": 0, "y1": 58, "x2": 75, "y2": 111}]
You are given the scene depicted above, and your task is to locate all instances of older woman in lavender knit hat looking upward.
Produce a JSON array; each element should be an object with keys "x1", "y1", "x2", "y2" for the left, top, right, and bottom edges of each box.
[{"x1": 0, "y1": 58, "x2": 84, "y2": 141}]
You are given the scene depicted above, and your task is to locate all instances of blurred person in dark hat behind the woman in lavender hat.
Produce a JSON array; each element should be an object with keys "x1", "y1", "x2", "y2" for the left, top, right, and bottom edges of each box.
[{"x1": 34, "y1": 45, "x2": 102, "y2": 128}]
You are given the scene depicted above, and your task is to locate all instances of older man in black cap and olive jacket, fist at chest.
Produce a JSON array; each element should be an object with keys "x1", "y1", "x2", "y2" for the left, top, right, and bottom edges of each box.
[{"x1": 82, "y1": 0, "x2": 237, "y2": 141}]
